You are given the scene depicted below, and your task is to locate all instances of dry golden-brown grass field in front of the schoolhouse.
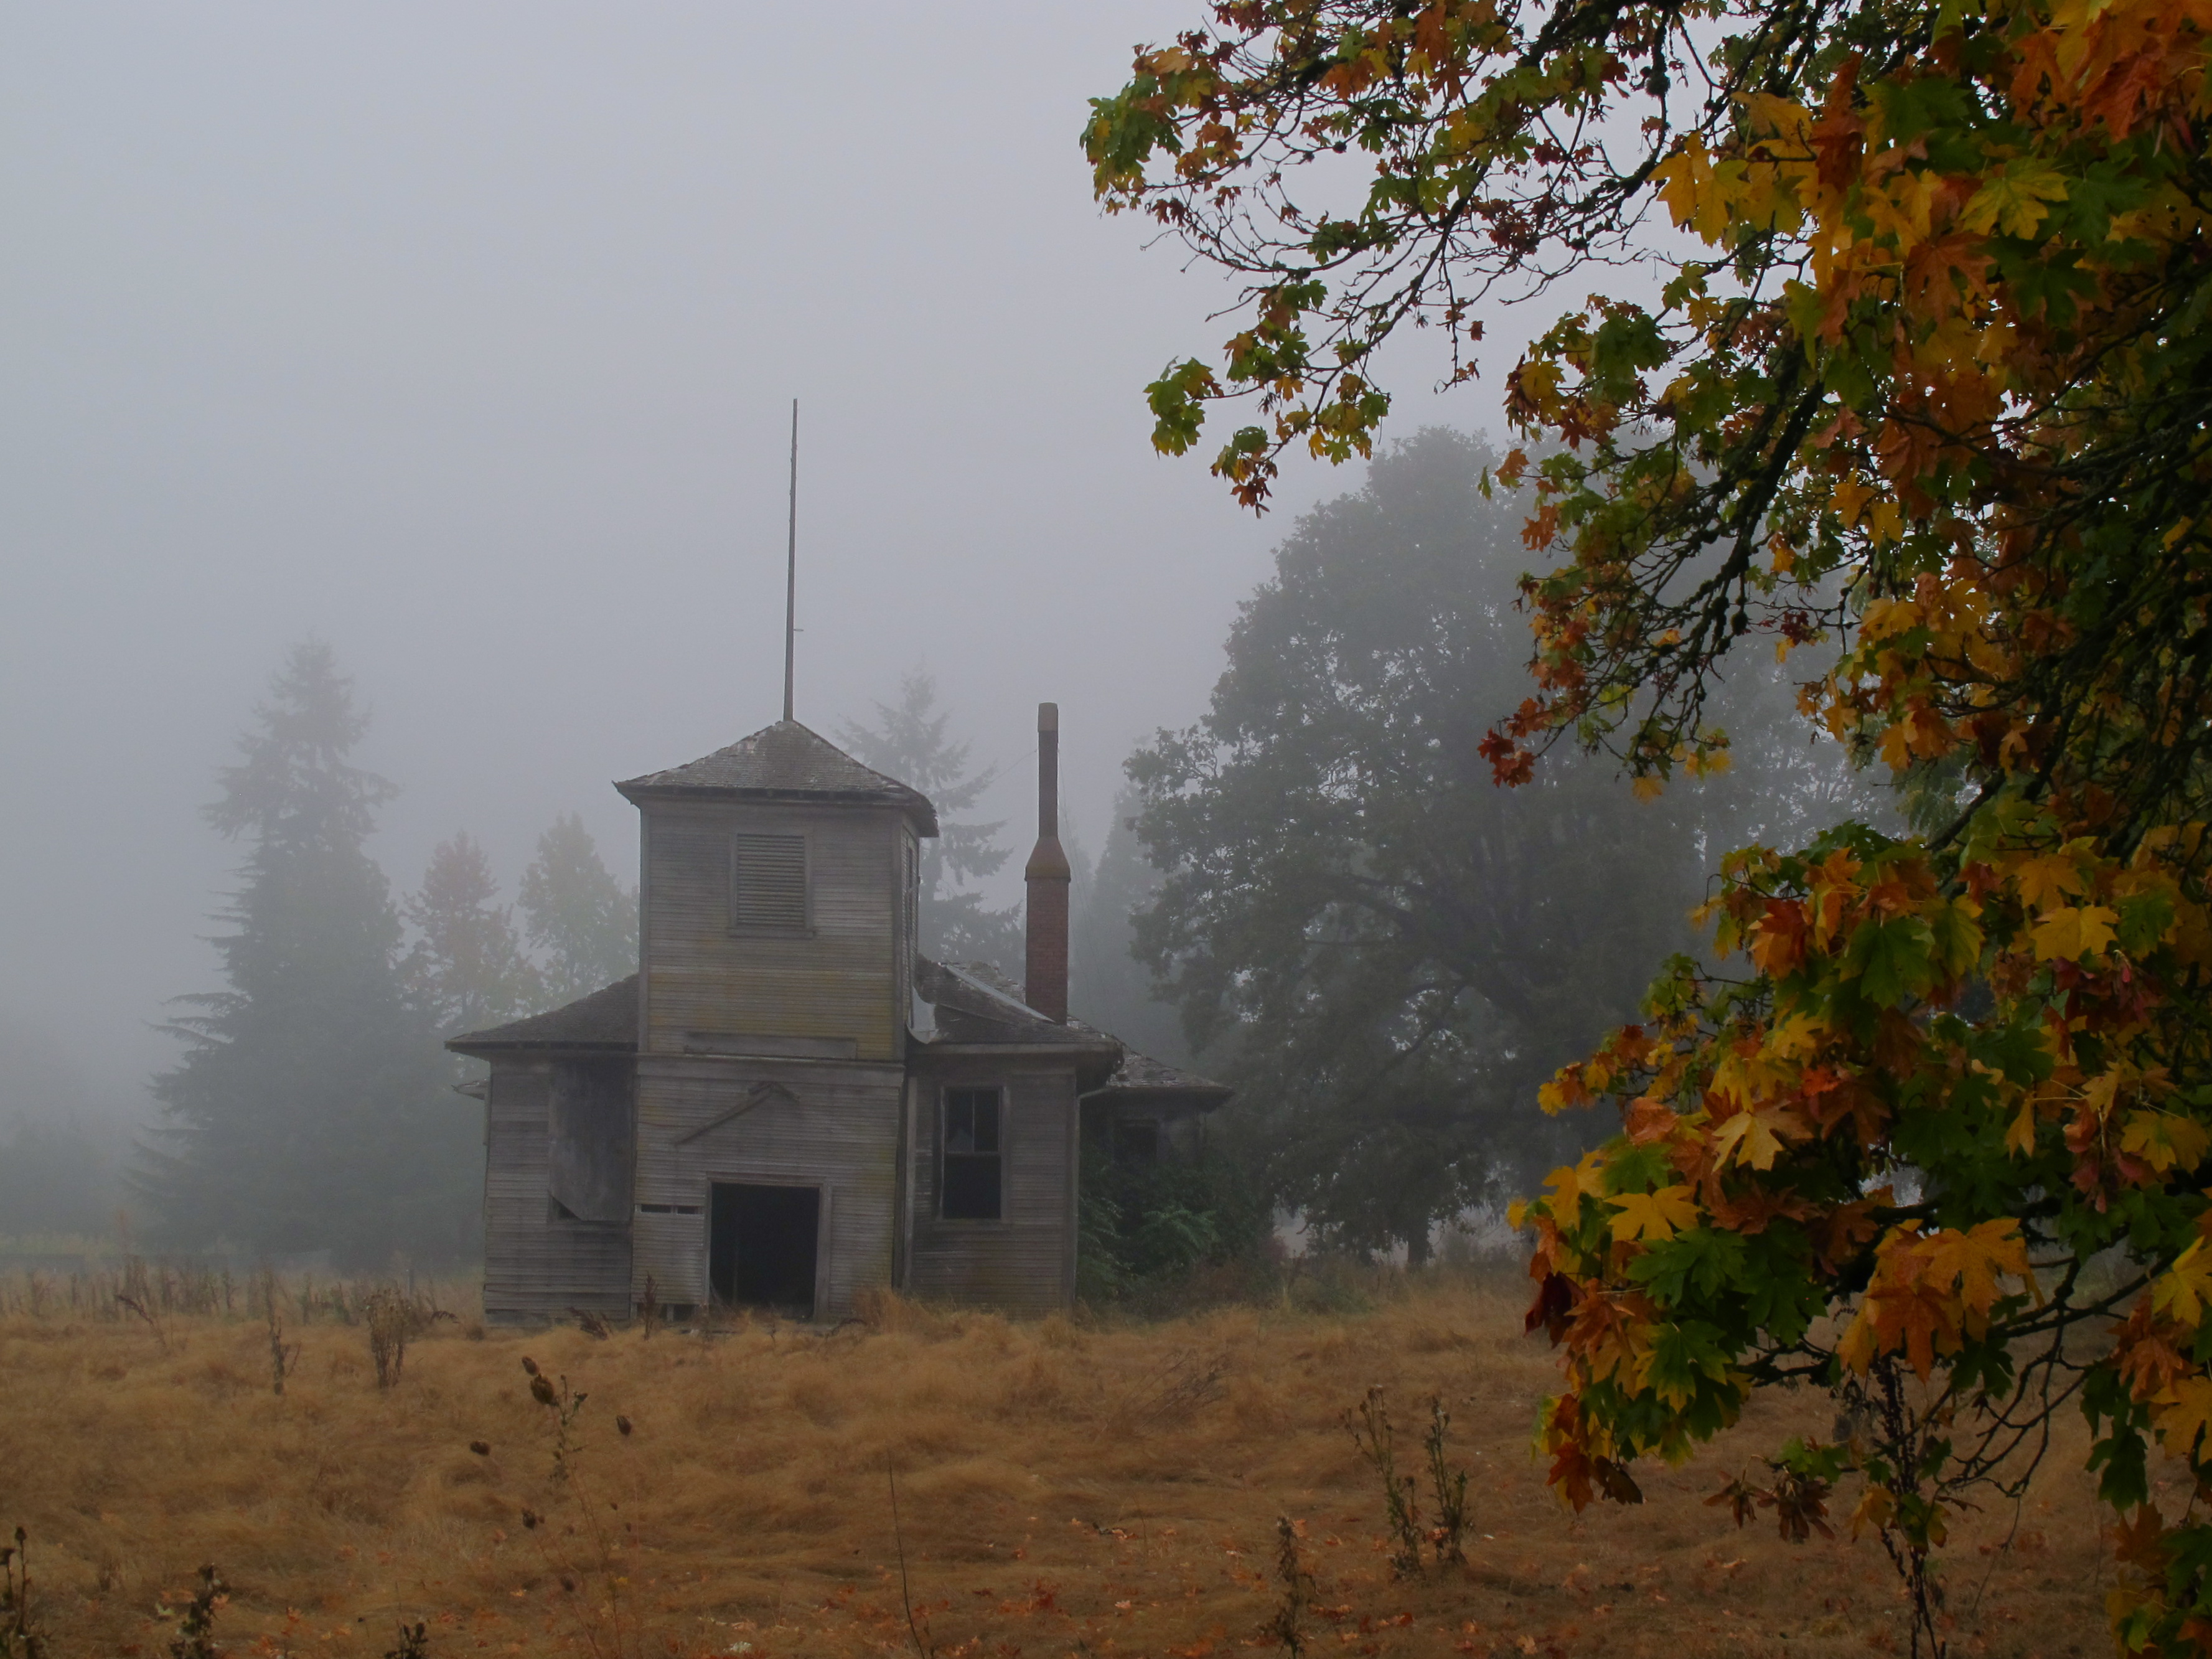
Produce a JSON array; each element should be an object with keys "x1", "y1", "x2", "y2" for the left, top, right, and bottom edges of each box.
[{"x1": 0, "y1": 1274, "x2": 2111, "y2": 1659}]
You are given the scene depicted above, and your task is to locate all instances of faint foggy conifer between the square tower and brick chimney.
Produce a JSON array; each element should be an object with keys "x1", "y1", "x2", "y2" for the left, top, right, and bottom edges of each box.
[{"x1": 838, "y1": 668, "x2": 1022, "y2": 971}]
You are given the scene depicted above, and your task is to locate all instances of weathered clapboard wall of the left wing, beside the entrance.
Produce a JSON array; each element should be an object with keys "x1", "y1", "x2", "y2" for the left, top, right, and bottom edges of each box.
[{"x1": 484, "y1": 1060, "x2": 630, "y2": 1323}]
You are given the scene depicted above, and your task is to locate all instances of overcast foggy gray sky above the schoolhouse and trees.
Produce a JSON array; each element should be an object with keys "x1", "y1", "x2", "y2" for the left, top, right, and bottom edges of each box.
[{"x1": 0, "y1": 0, "x2": 1517, "y2": 1132}]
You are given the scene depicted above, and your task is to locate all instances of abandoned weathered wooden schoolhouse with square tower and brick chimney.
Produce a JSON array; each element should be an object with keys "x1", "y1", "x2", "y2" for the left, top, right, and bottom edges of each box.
[{"x1": 447, "y1": 703, "x2": 1230, "y2": 1323}]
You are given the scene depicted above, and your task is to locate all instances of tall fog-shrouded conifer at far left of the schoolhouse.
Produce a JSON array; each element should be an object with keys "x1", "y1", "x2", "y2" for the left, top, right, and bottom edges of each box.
[{"x1": 133, "y1": 641, "x2": 482, "y2": 1266}]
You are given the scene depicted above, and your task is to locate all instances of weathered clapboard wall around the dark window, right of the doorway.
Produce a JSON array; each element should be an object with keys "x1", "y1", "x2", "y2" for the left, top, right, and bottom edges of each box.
[{"x1": 902, "y1": 1055, "x2": 1079, "y2": 1314}]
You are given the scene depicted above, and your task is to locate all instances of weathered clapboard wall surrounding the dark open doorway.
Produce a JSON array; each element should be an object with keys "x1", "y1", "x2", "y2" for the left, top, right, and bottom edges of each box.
[{"x1": 630, "y1": 1057, "x2": 905, "y2": 1320}]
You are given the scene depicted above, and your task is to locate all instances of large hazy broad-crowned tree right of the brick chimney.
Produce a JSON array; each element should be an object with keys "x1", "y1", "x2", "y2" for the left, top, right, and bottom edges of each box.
[{"x1": 1130, "y1": 429, "x2": 1743, "y2": 1261}]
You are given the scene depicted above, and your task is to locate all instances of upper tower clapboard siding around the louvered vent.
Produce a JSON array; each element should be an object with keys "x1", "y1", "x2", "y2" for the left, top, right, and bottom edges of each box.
[{"x1": 642, "y1": 801, "x2": 911, "y2": 1062}]
